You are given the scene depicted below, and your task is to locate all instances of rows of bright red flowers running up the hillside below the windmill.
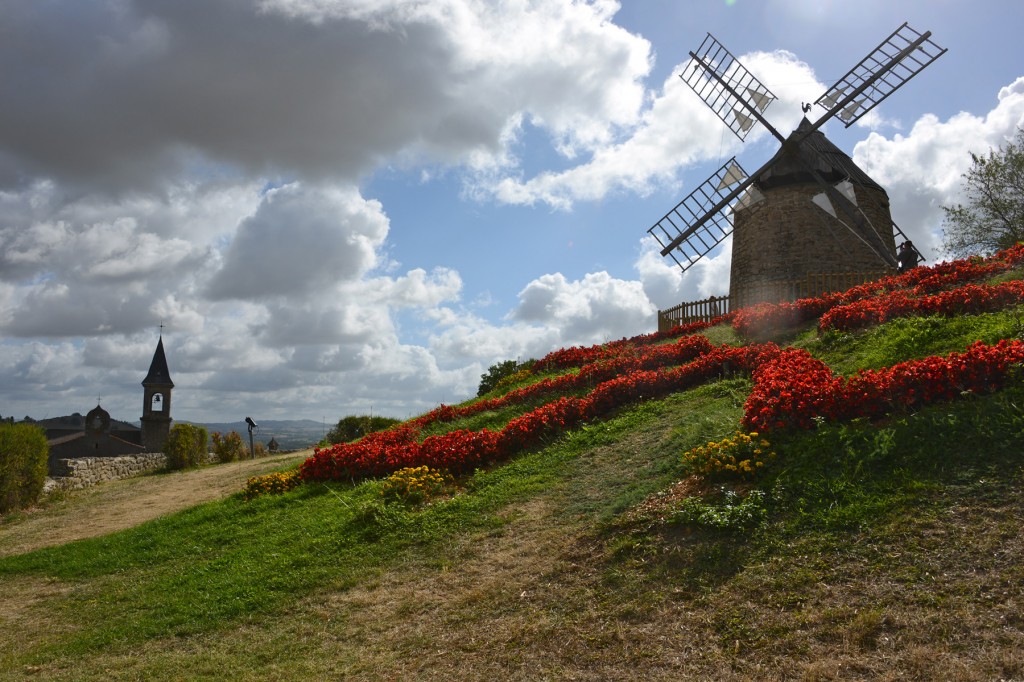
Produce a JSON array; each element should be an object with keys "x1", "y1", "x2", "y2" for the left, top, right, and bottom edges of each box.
[{"x1": 300, "y1": 245, "x2": 1024, "y2": 481}]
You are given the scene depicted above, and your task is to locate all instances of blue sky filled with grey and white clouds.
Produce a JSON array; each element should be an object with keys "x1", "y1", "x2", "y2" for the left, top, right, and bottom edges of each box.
[{"x1": 0, "y1": 0, "x2": 1024, "y2": 425}]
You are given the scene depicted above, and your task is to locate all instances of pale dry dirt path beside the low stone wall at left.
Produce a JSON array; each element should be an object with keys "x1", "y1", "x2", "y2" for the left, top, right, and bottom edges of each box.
[{"x1": 0, "y1": 451, "x2": 311, "y2": 556}]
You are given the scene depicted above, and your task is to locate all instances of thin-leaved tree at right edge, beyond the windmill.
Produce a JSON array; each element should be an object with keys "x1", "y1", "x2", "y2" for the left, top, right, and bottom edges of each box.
[{"x1": 942, "y1": 128, "x2": 1024, "y2": 257}]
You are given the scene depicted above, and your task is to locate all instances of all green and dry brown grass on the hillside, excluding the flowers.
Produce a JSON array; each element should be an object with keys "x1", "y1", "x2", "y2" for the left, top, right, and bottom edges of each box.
[{"x1": 0, "y1": 288, "x2": 1024, "y2": 679}]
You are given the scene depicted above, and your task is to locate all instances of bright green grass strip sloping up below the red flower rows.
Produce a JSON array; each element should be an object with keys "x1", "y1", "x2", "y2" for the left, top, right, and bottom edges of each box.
[{"x1": 0, "y1": 382, "x2": 739, "y2": 655}]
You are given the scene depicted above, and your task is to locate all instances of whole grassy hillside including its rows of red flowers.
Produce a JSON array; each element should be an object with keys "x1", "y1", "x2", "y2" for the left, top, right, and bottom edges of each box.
[{"x1": 0, "y1": 246, "x2": 1024, "y2": 680}]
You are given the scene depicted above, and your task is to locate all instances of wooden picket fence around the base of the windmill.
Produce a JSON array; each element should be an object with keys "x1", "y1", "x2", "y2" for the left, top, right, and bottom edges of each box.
[{"x1": 657, "y1": 272, "x2": 891, "y2": 332}]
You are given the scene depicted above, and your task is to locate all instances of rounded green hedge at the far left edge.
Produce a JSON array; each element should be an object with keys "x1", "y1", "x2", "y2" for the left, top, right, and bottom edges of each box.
[{"x1": 0, "y1": 424, "x2": 49, "y2": 513}]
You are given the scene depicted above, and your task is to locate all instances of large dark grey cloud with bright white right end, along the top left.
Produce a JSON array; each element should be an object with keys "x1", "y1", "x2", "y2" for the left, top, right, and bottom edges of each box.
[{"x1": 0, "y1": 0, "x2": 650, "y2": 193}]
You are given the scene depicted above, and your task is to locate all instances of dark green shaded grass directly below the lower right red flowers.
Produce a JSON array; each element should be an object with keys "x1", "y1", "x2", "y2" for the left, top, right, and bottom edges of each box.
[{"x1": 764, "y1": 376, "x2": 1024, "y2": 534}]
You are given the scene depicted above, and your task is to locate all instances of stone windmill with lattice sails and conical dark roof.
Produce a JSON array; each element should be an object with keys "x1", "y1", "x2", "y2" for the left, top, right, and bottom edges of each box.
[{"x1": 647, "y1": 24, "x2": 946, "y2": 307}]
